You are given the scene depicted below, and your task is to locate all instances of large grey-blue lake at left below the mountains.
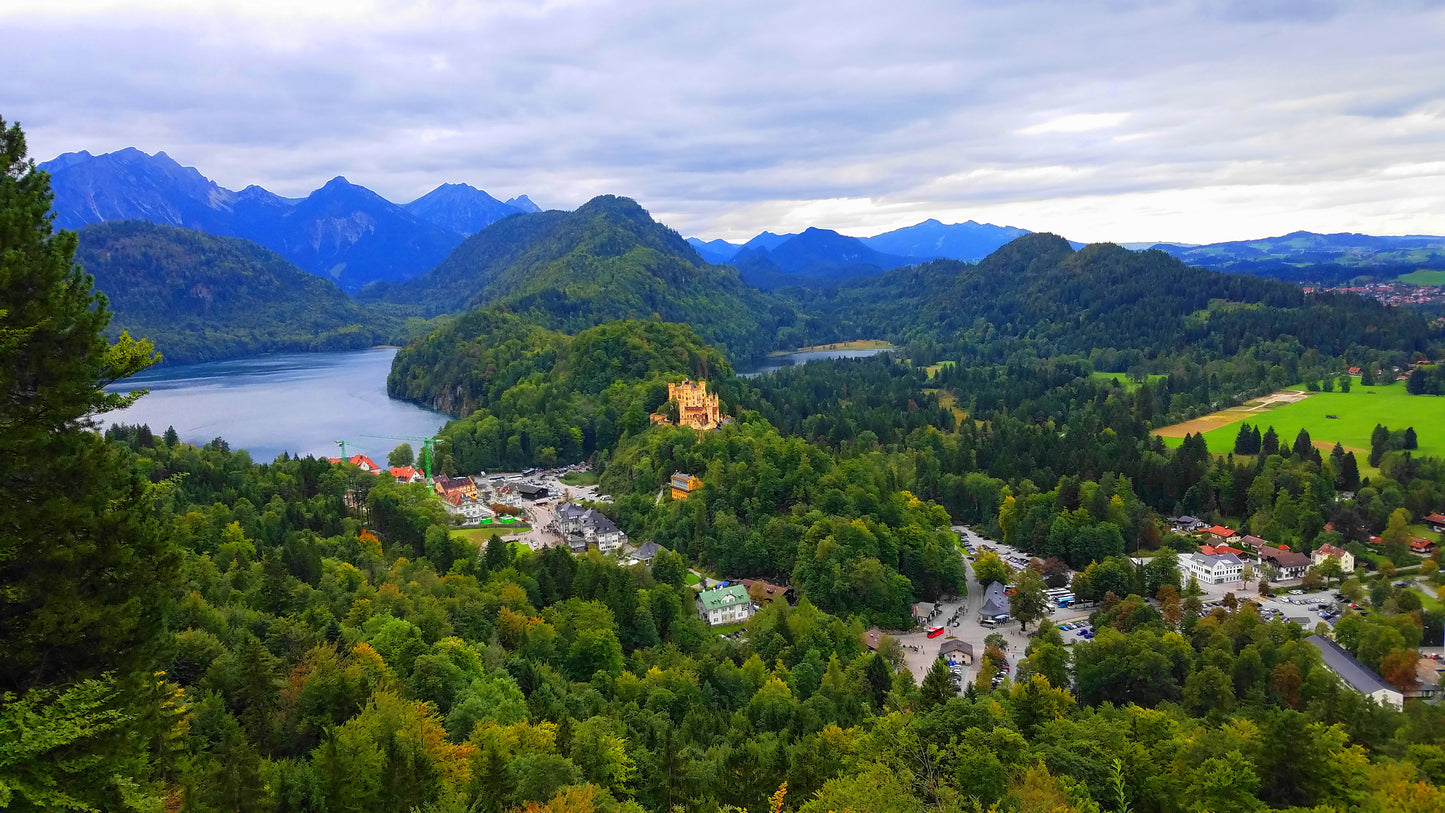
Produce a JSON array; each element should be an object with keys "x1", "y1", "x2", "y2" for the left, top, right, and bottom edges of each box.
[{"x1": 101, "y1": 348, "x2": 448, "y2": 465}]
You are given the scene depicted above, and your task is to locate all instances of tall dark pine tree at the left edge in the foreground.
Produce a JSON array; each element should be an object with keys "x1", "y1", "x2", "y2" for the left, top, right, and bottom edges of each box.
[{"x1": 0, "y1": 120, "x2": 176, "y2": 690}]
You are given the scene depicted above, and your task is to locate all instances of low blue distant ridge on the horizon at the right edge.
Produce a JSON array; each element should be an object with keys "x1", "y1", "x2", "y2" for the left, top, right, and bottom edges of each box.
[{"x1": 1153, "y1": 231, "x2": 1445, "y2": 284}]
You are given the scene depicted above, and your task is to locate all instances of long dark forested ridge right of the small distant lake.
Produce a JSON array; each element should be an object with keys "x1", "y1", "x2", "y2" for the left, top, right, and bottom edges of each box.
[{"x1": 792, "y1": 234, "x2": 1429, "y2": 357}]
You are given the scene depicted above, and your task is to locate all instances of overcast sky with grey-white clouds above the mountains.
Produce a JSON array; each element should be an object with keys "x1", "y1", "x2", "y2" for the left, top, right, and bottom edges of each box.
[{"x1": 0, "y1": 0, "x2": 1445, "y2": 243}]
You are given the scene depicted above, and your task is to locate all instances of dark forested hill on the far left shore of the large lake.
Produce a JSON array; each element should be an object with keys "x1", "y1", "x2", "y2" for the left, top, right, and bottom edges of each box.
[{"x1": 75, "y1": 221, "x2": 394, "y2": 362}]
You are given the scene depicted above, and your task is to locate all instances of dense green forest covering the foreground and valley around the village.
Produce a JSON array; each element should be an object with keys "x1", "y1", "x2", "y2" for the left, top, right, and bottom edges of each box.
[{"x1": 14, "y1": 116, "x2": 1445, "y2": 813}]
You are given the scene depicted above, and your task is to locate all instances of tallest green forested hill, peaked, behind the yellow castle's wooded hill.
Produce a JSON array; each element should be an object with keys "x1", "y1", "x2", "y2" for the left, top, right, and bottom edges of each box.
[{"x1": 364, "y1": 195, "x2": 803, "y2": 358}]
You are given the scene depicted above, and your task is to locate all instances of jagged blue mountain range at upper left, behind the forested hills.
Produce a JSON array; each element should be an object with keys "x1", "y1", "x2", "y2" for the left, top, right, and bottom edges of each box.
[{"x1": 40, "y1": 147, "x2": 539, "y2": 292}]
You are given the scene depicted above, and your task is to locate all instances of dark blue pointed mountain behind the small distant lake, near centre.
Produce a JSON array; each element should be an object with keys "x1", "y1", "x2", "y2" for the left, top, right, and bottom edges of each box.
[{"x1": 731, "y1": 228, "x2": 912, "y2": 290}]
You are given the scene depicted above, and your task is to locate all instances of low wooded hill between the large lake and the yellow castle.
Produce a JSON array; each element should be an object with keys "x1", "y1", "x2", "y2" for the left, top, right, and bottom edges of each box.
[{"x1": 386, "y1": 317, "x2": 733, "y2": 472}]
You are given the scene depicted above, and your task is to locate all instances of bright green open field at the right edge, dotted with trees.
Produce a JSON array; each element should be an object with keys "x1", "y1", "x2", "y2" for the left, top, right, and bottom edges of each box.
[{"x1": 1165, "y1": 384, "x2": 1445, "y2": 462}]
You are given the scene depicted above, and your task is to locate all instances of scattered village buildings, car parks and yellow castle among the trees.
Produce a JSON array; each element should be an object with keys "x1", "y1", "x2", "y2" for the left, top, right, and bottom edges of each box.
[{"x1": 331, "y1": 380, "x2": 1445, "y2": 708}]
